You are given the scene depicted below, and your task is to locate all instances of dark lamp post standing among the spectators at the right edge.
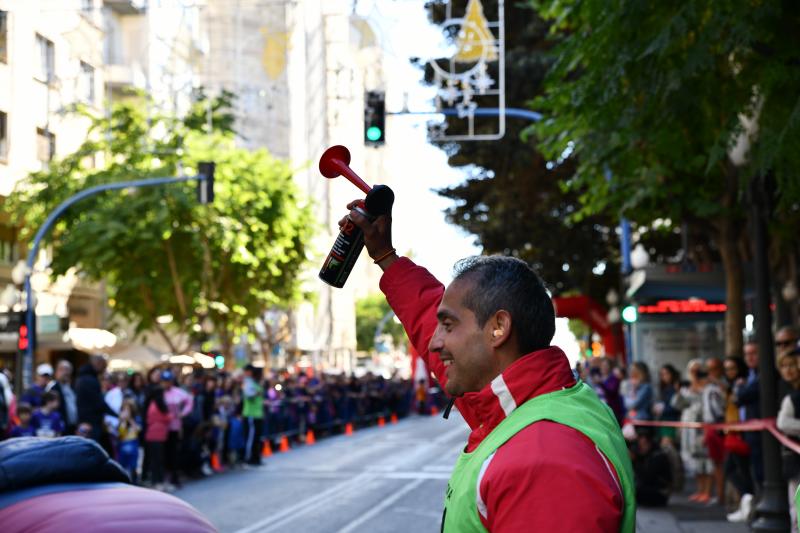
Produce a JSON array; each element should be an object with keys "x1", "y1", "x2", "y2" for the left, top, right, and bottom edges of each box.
[{"x1": 750, "y1": 172, "x2": 789, "y2": 531}]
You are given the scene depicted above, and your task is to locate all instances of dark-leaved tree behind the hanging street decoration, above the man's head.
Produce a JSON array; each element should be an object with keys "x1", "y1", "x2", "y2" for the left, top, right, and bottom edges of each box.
[{"x1": 426, "y1": 0, "x2": 619, "y2": 302}]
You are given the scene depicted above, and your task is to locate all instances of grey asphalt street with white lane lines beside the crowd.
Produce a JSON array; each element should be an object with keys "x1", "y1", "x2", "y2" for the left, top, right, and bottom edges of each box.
[{"x1": 175, "y1": 412, "x2": 468, "y2": 533}]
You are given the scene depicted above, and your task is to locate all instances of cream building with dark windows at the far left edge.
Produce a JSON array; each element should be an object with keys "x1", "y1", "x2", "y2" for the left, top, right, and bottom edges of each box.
[{"x1": 0, "y1": 0, "x2": 112, "y2": 382}]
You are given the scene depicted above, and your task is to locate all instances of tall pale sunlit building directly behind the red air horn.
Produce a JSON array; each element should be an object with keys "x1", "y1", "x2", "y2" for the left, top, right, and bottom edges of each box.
[{"x1": 201, "y1": 0, "x2": 383, "y2": 371}]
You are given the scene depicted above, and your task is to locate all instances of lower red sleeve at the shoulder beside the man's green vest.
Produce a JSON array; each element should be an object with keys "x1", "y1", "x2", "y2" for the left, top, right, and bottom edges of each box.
[{"x1": 477, "y1": 420, "x2": 623, "y2": 533}]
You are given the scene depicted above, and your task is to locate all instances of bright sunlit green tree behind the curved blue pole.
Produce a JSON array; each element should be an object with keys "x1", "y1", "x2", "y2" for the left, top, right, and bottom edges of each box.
[{"x1": 10, "y1": 94, "x2": 312, "y2": 355}]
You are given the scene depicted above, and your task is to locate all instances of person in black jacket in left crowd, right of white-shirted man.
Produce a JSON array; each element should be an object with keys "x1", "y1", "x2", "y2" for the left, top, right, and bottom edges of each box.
[{"x1": 75, "y1": 355, "x2": 117, "y2": 455}]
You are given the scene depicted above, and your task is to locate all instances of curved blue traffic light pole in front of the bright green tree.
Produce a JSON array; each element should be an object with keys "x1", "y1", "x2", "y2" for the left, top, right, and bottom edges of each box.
[{"x1": 20, "y1": 171, "x2": 214, "y2": 390}]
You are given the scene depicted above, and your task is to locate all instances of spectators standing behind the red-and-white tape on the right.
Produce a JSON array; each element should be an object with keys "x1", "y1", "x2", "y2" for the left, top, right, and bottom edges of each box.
[{"x1": 576, "y1": 327, "x2": 800, "y2": 531}]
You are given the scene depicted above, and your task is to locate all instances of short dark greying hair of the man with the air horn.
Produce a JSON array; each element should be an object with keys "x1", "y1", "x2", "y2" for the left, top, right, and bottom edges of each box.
[{"x1": 453, "y1": 255, "x2": 556, "y2": 354}]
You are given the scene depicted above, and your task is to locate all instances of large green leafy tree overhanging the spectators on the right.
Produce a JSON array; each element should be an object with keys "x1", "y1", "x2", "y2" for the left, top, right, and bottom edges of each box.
[{"x1": 531, "y1": 0, "x2": 800, "y2": 355}]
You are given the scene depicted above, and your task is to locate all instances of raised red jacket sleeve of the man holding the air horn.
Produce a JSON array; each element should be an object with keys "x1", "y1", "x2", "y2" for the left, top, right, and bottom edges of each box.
[{"x1": 380, "y1": 257, "x2": 477, "y2": 428}]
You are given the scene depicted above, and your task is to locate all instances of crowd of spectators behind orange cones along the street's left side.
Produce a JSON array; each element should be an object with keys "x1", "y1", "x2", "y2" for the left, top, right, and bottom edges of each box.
[{"x1": 0, "y1": 356, "x2": 444, "y2": 491}]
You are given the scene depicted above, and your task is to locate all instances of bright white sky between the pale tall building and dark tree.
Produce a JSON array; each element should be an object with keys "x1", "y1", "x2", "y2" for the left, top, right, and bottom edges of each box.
[{"x1": 355, "y1": 0, "x2": 579, "y2": 365}]
